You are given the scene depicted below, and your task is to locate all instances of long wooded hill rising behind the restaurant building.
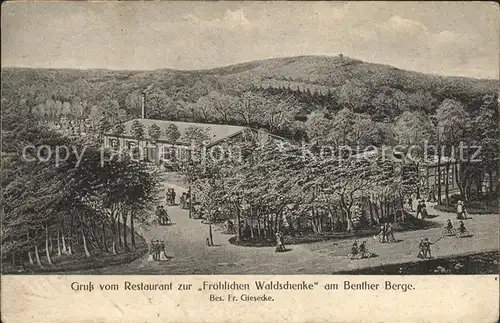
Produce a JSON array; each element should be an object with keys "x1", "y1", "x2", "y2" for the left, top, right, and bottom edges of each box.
[{"x1": 2, "y1": 55, "x2": 499, "y2": 137}]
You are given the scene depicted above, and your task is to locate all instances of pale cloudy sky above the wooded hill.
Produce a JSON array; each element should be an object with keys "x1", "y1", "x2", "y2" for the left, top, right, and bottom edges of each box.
[{"x1": 1, "y1": 2, "x2": 500, "y2": 78}]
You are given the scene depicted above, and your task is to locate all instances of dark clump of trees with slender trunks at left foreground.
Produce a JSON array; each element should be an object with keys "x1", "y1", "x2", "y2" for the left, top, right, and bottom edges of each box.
[{"x1": 1, "y1": 105, "x2": 156, "y2": 265}]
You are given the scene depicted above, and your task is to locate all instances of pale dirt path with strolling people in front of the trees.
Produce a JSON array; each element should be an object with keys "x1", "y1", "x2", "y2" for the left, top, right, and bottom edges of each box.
[{"x1": 80, "y1": 178, "x2": 499, "y2": 274}]
